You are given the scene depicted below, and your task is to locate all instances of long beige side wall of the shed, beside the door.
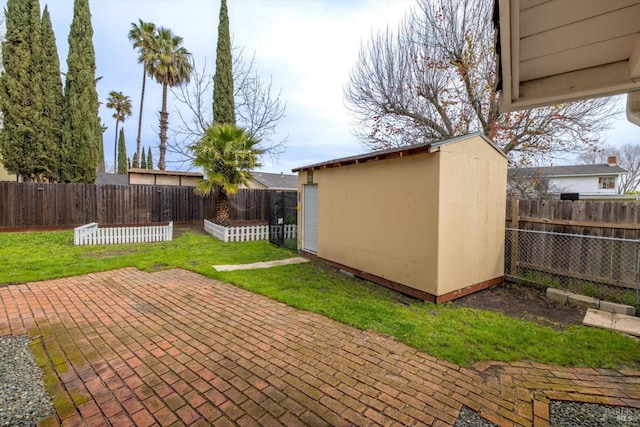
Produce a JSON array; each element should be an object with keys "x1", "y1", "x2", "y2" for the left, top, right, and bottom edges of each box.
[{"x1": 299, "y1": 154, "x2": 438, "y2": 294}]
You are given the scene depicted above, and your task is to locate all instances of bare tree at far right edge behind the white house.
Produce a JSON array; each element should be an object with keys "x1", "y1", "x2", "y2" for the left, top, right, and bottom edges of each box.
[{"x1": 578, "y1": 143, "x2": 640, "y2": 194}]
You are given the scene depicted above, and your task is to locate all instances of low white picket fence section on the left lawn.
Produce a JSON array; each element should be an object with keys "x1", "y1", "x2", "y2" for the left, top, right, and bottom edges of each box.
[{"x1": 73, "y1": 221, "x2": 173, "y2": 246}]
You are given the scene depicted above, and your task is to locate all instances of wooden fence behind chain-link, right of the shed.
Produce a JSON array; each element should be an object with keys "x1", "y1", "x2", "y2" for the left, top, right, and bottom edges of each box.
[{"x1": 505, "y1": 200, "x2": 640, "y2": 288}]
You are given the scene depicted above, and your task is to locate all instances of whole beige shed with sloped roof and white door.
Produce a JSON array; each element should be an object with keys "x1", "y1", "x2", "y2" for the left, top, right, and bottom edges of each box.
[{"x1": 294, "y1": 133, "x2": 508, "y2": 303}]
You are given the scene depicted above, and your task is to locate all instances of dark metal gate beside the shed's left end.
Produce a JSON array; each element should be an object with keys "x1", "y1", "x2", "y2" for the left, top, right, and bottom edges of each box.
[{"x1": 268, "y1": 190, "x2": 298, "y2": 249}]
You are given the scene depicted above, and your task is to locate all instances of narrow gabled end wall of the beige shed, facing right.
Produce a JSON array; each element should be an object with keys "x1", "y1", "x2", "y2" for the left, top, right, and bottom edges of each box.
[{"x1": 436, "y1": 137, "x2": 507, "y2": 295}]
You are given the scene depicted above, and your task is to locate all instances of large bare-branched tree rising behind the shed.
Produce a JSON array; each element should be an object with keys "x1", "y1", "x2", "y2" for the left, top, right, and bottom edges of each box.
[{"x1": 345, "y1": 0, "x2": 616, "y2": 164}]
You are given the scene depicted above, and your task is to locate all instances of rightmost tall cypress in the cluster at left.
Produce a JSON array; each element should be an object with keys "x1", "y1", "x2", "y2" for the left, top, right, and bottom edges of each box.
[{"x1": 60, "y1": 0, "x2": 102, "y2": 183}]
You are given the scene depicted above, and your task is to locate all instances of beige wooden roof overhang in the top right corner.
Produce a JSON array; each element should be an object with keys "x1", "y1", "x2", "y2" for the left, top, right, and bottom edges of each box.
[{"x1": 493, "y1": 0, "x2": 640, "y2": 112}]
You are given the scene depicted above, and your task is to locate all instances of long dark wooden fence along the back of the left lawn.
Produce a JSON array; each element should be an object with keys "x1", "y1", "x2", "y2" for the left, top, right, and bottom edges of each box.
[{"x1": 0, "y1": 182, "x2": 268, "y2": 228}]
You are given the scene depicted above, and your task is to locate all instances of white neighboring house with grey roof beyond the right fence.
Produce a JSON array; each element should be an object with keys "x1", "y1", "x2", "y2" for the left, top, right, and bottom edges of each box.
[{"x1": 507, "y1": 156, "x2": 628, "y2": 198}]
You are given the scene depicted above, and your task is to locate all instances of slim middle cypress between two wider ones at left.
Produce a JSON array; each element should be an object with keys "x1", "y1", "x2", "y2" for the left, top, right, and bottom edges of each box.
[{"x1": 40, "y1": 6, "x2": 64, "y2": 181}]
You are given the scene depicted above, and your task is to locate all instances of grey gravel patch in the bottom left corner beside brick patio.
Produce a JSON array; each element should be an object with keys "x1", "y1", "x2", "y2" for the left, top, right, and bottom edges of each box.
[{"x1": 0, "y1": 335, "x2": 55, "y2": 427}]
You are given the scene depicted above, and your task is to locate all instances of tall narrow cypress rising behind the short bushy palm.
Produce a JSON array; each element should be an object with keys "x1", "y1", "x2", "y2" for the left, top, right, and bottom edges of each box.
[{"x1": 213, "y1": 0, "x2": 236, "y2": 125}]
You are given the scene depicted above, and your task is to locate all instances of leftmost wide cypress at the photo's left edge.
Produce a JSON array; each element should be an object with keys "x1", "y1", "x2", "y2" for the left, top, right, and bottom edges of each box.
[{"x1": 0, "y1": 0, "x2": 46, "y2": 181}]
